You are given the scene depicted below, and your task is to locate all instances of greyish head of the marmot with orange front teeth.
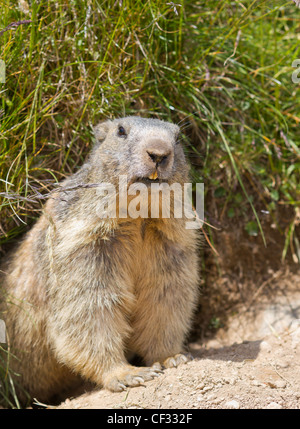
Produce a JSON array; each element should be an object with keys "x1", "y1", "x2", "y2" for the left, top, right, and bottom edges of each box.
[{"x1": 91, "y1": 116, "x2": 188, "y2": 185}]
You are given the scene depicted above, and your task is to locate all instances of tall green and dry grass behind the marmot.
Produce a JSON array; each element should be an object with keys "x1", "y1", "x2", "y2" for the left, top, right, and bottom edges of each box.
[{"x1": 0, "y1": 0, "x2": 300, "y2": 406}]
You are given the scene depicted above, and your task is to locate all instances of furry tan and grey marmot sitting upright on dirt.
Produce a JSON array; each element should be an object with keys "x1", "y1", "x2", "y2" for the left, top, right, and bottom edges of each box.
[{"x1": 0, "y1": 116, "x2": 198, "y2": 401}]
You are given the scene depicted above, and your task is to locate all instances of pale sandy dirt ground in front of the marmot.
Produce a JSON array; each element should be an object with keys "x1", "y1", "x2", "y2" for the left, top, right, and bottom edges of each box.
[{"x1": 57, "y1": 273, "x2": 300, "y2": 409}]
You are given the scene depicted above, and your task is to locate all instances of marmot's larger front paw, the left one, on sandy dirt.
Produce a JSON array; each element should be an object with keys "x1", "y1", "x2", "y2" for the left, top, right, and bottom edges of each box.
[{"x1": 103, "y1": 365, "x2": 162, "y2": 392}]
